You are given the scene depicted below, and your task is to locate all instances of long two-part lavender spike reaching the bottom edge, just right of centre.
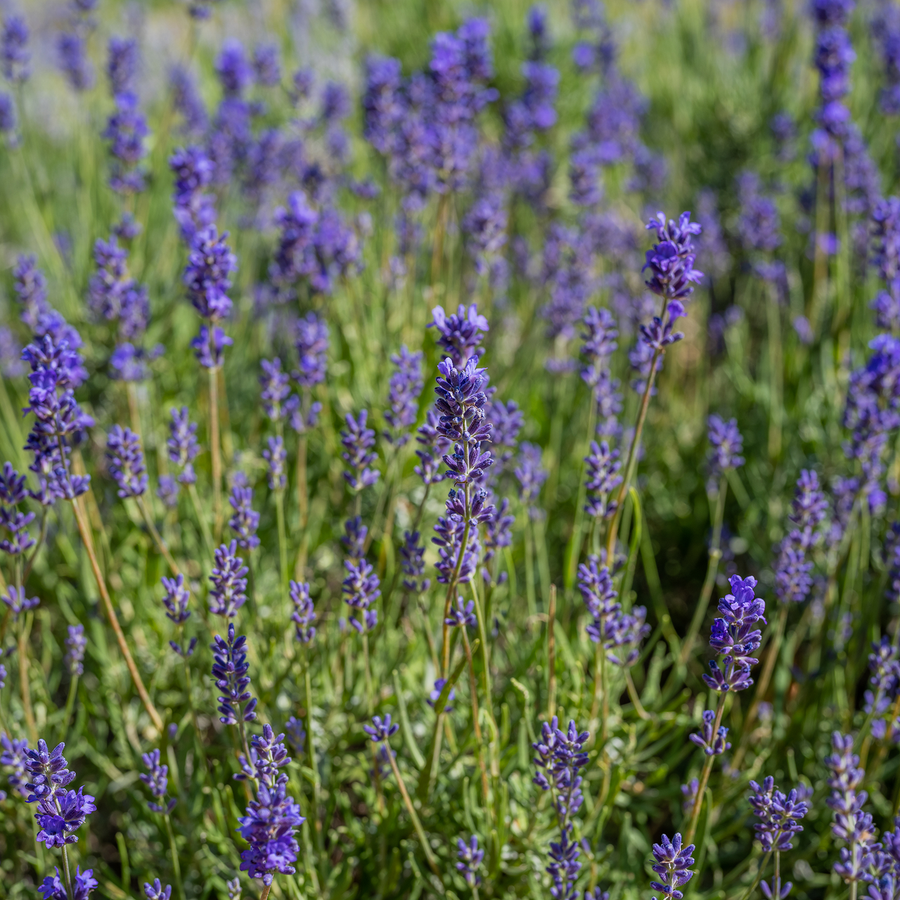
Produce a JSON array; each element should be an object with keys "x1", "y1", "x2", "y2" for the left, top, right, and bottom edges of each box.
[{"x1": 532, "y1": 716, "x2": 591, "y2": 900}]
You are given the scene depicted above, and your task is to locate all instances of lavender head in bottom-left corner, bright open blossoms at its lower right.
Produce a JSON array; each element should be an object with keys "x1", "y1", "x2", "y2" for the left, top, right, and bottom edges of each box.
[{"x1": 25, "y1": 740, "x2": 97, "y2": 848}]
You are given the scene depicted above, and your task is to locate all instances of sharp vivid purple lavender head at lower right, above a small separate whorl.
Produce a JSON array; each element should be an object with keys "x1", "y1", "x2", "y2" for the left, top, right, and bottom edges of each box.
[{"x1": 703, "y1": 575, "x2": 766, "y2": 693}]
